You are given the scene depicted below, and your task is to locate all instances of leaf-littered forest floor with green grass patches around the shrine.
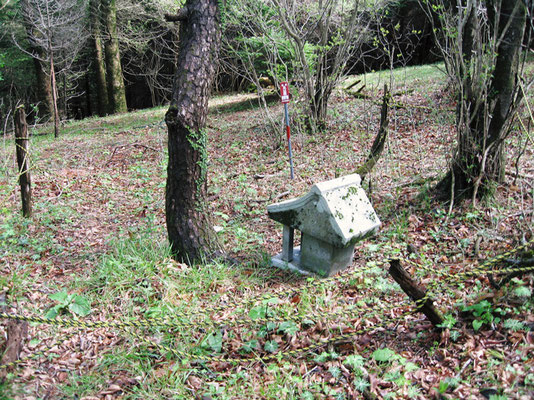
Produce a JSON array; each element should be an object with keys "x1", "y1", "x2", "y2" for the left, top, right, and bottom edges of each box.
[{"x1": 0, "y1": 66, "x2": 534, "y2": 400}]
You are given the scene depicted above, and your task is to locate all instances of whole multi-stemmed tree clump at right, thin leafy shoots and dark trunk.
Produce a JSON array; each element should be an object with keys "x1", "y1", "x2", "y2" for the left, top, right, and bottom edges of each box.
[{"x1": 423, "y1": 0, "x2": 527, "y2": 202}]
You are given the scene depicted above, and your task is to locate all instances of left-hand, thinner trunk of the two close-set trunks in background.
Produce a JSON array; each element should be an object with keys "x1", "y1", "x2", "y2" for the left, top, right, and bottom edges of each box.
[{"x1": 89, "y1": 0, "x2": 109, "y2": 117}]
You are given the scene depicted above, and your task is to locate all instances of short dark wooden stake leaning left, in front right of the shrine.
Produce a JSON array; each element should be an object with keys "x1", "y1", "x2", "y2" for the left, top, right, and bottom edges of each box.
[{"x1": 389, "y1": 260, "x2": 443, "y2": 327}]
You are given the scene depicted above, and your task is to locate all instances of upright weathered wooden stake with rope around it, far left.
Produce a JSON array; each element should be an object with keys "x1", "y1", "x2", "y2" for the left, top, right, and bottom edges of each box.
[{"x1": 15, "y1": 106, "x2": 32, "y2": 217}]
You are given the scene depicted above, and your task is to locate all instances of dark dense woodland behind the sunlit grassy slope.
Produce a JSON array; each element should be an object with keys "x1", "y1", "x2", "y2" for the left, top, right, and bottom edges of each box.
[{"x1": 0, "y1": 0, "x2": 439, "y2": 126}]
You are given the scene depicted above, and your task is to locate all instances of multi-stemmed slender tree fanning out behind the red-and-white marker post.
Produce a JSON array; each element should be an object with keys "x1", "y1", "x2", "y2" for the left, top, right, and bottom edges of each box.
[{"x1": 270, "y1": 0, "x2": 369, "y2": 132}]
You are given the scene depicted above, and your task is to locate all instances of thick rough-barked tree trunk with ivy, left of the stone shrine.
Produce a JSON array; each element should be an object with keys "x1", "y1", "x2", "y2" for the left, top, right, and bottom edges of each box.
[{"x1": 165, "y1": 0, "x2": 220, "y2": 262}]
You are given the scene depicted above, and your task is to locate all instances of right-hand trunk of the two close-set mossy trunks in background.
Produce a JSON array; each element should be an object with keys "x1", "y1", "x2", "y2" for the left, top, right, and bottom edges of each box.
[{"x1": 102, "y1": 0, "x2": 128, "y2": 114}]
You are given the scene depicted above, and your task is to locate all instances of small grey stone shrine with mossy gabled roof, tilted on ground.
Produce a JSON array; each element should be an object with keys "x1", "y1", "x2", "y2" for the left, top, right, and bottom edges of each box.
[{"x1": 267, "y1": 174, "x2": 380, "y2": 276}]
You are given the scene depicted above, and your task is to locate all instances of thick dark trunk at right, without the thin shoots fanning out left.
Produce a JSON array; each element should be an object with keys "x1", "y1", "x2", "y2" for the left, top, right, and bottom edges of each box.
[{"x1": 437, "y1": 0, "x2": 526, "y2": 200}]
